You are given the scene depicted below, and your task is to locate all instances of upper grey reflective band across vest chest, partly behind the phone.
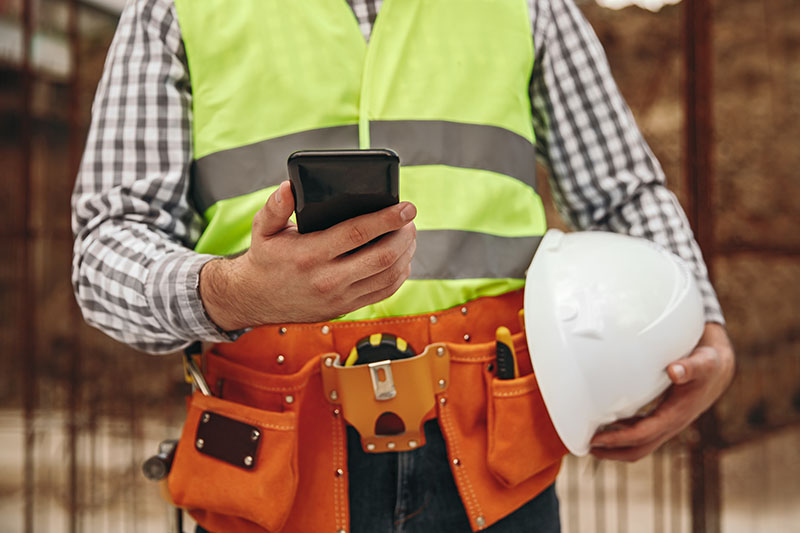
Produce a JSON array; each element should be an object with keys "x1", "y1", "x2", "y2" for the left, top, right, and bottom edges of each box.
[{"x1": 191, "y1": 120, "x2": 536, "y2": 213}]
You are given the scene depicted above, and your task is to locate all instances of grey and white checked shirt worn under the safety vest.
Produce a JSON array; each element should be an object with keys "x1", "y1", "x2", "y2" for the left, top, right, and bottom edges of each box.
[{"x1": 72, "y1": 0, "x2": 723, "y2": 353}]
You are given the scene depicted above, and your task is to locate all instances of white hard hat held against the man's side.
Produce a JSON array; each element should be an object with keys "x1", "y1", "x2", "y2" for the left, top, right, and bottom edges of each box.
[{"x1": 525, "y1": 230, "x2": 704, "y2": 455}]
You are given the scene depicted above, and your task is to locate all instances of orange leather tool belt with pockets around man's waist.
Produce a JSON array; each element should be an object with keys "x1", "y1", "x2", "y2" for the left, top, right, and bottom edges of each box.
[{"x1": 167, "y1": 291, "x2": 566, "y2": 533}]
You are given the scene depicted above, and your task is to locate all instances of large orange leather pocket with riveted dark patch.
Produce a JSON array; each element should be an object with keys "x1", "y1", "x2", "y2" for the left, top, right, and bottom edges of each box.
[{"x1": 167, "y1": 392, "x2": 298, "y2": 531}]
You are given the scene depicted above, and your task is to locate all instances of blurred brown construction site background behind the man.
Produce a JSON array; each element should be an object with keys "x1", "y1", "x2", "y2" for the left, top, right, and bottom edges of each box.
[{"x1": 0, "y1": 0, "x2": 800, "y2": 533}]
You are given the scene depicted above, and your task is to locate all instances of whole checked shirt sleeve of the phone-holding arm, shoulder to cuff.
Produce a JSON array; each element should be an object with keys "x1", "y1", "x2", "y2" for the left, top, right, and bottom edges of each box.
[{"x1": 72, "y1": 0, "x2": 224, "y2": 353}]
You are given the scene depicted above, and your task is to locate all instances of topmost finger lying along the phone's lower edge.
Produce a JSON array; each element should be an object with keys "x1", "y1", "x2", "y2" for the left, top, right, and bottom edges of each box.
[{"x1": 320, "y1": 202, "x2": 417, "y2": 258}]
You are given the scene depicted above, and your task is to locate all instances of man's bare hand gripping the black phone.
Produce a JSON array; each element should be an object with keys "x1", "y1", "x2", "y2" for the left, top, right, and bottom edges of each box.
[{"x1": 200, "y1": 181, "x2": 417, "y2": 331}]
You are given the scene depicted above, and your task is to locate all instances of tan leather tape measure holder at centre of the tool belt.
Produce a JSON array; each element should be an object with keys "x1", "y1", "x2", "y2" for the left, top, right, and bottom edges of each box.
[{"x1": 320, "y1": 343, "x2": 450, "y2": 453}]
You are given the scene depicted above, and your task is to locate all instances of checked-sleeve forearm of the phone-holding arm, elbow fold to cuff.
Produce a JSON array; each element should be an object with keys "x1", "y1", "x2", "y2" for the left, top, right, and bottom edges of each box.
[{"x1": 72, "y1": 221, "x2": 226, "y2": 353}]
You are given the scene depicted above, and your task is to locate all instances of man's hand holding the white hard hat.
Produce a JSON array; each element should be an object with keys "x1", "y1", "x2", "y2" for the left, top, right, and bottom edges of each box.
[{"x1": 591, "y1": 323, "x2": 734, "y2": 461}]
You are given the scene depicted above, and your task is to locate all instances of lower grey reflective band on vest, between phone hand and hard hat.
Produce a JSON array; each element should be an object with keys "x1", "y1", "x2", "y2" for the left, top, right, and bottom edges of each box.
[{"x1": 410, "y1": 230, "x2": 541, "y2": 279}]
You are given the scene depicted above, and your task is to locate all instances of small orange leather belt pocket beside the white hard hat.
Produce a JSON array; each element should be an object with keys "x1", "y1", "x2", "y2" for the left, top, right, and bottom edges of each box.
[{"x1": 486, "y1": 373, "x2": 566, "y2": 487}]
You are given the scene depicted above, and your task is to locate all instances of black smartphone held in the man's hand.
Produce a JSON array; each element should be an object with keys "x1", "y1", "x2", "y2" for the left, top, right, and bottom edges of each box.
[{"x1": 288, "y1": 148, "x2": 400, "y2": 233}]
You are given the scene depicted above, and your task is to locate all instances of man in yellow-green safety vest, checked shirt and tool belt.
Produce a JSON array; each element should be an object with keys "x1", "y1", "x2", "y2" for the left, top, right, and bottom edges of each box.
[{"x1": 73, "y1": 0, "x2": 734, "y2": 532}]
